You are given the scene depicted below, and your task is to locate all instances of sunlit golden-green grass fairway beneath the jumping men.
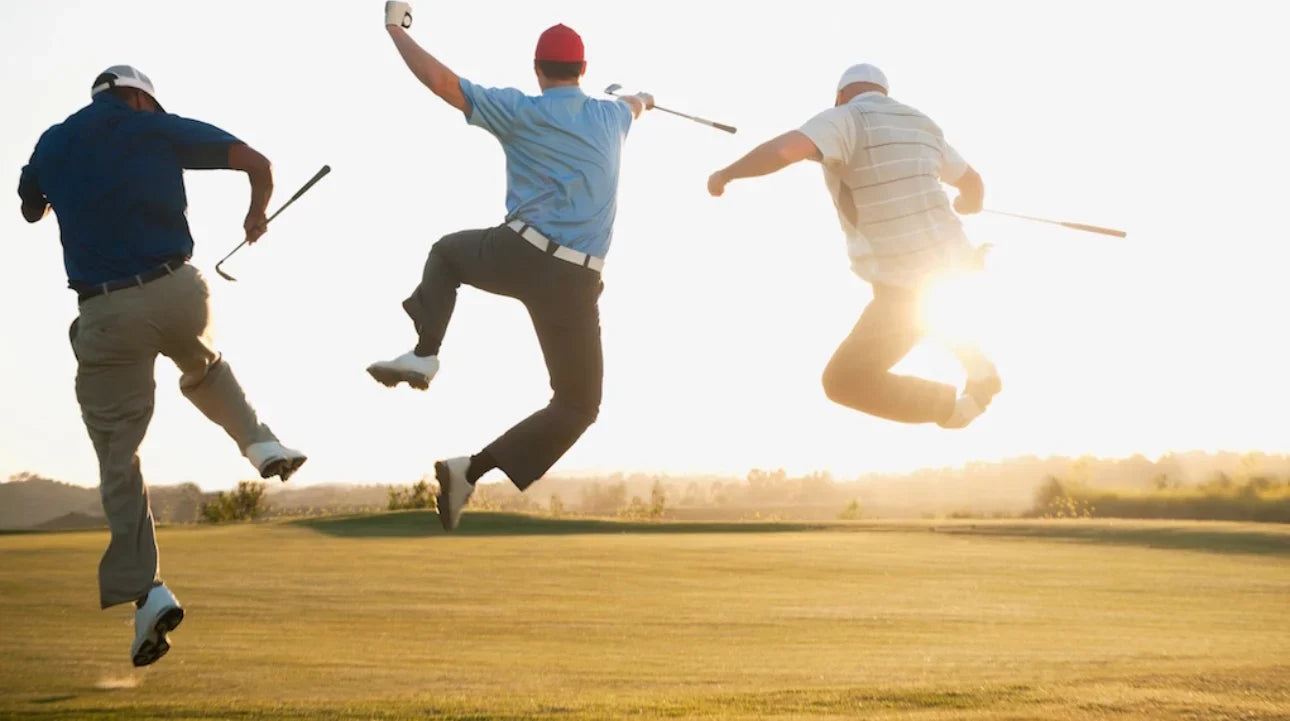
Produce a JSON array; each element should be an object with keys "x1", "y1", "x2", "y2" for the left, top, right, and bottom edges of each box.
[{"x1": 0, "y1": 512, "x2": 1290, "y2": 721}]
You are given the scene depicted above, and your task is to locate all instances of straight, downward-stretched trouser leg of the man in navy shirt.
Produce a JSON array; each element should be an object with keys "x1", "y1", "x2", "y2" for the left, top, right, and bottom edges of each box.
[{"x1": 71, "y1": 304, "x2": 161, "y2": 609}]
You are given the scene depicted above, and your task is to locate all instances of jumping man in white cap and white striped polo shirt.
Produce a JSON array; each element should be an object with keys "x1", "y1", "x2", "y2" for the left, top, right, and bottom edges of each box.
[{"x1": 708, "y1": 64, "x2": 1001, "y2": 428}]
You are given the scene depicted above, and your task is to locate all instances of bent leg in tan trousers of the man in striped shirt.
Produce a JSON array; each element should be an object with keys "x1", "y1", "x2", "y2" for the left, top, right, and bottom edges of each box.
[{"x1": 822, "y1": 286, "x2": 956, "y2": 423}]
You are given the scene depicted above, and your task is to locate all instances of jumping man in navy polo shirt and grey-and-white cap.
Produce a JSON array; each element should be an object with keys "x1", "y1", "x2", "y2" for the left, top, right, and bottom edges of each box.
[{"x1": 18, "y1": 66, "x2": 304, "y2": 666}]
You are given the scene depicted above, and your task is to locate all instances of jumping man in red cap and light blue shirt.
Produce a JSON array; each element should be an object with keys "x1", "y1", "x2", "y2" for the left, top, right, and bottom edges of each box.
[{"x1": 368, "y1": 3, "x2": 654, "y2": 530}]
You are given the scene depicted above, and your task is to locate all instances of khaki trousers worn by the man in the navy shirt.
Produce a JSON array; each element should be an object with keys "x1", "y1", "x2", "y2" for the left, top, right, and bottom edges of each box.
[{"x1": 71, "y1": 264, "x2": 276, "y2": 609}]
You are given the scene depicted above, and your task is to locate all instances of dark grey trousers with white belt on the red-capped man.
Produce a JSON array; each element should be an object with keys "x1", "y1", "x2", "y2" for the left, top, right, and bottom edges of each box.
[{"x1": 402, "y1": 224, "x2": 604, "y2": 490}]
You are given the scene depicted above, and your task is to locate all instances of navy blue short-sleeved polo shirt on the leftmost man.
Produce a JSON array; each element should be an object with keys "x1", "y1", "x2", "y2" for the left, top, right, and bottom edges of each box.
[{"x1": 18, "y1": 93, "x2": 239, "y2": 289}]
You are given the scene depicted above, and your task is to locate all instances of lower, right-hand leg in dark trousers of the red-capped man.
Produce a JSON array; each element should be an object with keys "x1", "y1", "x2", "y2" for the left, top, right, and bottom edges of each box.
[{"x1": 470, "y1": 273, "x2": 604, "y2": 490}]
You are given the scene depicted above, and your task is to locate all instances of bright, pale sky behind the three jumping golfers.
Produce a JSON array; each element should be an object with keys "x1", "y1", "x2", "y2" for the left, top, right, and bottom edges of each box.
[{"x1": 0, "y1": 0, "x2": 1290, "y2": 489}]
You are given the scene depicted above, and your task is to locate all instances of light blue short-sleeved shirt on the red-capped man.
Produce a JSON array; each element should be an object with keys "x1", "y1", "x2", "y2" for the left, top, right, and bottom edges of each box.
[{"x1": 461, "y1": 79, "x2": 632, "y2": 258}]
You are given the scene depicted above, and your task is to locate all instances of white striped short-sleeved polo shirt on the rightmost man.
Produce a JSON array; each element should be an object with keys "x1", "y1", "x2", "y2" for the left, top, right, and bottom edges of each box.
[{"x1": 800, "y1": 92, "x2": 973, "y2": 288}]
